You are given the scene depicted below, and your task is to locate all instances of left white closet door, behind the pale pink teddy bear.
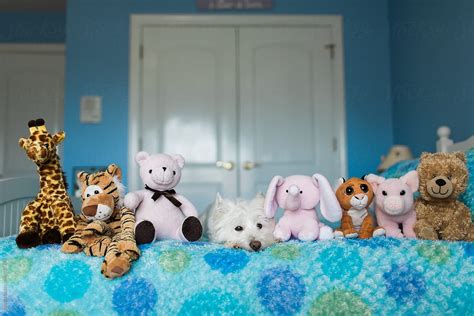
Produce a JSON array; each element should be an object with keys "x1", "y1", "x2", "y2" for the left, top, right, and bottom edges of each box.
[{"x1": 139, "y1": 27, "x2": 237, "y2": 211}]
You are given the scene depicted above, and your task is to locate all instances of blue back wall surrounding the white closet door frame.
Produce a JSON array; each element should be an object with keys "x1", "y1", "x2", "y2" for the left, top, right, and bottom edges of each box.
[{"x1": 64, "y1": 0, "x2": 393, "y2": 188}]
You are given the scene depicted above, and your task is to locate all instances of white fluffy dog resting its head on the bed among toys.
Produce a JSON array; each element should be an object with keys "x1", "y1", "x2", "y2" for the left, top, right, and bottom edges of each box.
[{"x1": 201, "y1": 193, "x2": 276, "y2": 251}]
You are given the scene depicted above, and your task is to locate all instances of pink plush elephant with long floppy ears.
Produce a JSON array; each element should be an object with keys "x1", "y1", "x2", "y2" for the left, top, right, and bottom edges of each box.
[{"x1": 264, "y1": 173, "x2": 342, "y2": 241}]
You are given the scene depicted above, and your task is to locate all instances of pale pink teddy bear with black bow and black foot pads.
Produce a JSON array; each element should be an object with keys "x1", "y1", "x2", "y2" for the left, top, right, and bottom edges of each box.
[{"x1": 125, "y1": 151, "x2": 202, "y2": 244}]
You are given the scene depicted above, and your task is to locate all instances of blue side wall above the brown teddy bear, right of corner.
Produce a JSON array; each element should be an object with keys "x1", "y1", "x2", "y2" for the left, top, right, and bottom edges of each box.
[{"x1": 389, "y1": 0, "x2": 474, "y2": 155}]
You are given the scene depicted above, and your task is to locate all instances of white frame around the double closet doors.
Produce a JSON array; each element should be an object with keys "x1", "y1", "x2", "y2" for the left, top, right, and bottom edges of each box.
[{"x1": 128, "y1": 14, "x2": 347, "y2": 190}]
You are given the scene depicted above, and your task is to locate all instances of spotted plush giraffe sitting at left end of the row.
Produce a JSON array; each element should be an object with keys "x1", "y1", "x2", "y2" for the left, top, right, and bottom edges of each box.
[{"x1": 16, "y1": 119, "x2": 75, "y2": 248}]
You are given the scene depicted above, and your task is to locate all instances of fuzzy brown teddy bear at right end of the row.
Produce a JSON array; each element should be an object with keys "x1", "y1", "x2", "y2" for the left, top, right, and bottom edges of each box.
[{"x1": 414, "y1": 152, "x2": 474, "y2": 240}]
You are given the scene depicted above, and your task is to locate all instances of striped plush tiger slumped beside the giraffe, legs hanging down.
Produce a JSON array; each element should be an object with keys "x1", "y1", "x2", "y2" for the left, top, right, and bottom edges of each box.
[{"x1": 61, "y1": 164, "x2": 140, "y2": 278}]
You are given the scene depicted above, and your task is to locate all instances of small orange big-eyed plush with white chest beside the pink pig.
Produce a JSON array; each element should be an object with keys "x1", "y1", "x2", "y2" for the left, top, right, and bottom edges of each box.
[{"x1": 334, "y1": 178, "x2": 385, "y2": 239}]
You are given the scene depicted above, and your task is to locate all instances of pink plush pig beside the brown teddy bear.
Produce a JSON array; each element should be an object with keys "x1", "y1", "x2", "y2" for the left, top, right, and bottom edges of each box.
[{"x1": 366, "y1": 171, "x2": 419, "y2": 238}]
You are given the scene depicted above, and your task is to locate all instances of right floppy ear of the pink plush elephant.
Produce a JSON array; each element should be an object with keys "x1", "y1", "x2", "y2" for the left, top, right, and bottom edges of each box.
[{"x1": 312, "y1": 173, "x2": 342, "y2": 222}]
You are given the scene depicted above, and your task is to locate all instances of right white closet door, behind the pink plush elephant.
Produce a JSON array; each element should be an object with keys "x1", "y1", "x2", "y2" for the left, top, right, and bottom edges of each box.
[{"x1": 238, "y1": 27, "x2": 343, "y2": 197}]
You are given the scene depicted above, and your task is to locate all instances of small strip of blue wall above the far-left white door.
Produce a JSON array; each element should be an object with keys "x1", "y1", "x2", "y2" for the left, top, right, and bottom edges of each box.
[{"x1": 0, "y1": 11, "x2": 66, "y2": 43}]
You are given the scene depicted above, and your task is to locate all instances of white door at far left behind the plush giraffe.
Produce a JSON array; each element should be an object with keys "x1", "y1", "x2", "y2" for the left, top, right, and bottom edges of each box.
[{"x1": 0, "y1": 49, "x2": 64, "y2": 177}]
